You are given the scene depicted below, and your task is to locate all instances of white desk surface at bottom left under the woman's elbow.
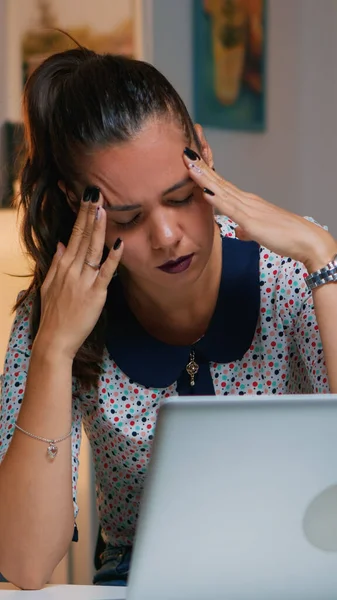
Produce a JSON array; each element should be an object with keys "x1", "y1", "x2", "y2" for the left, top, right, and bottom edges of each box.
[{"x1": 0, "y1": 583, "x2": 126, "y2": 600}]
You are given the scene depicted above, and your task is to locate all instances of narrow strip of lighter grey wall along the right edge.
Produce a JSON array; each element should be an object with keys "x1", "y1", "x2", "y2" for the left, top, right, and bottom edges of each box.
[{"x1": 299, "y1": 0, "x2": 337, "y2": 230}]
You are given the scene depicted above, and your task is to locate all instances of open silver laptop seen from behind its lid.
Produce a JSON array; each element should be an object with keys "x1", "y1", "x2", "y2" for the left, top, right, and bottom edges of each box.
[{"x1": 127, "y1": 395, "x2": 337, "y2": 600}]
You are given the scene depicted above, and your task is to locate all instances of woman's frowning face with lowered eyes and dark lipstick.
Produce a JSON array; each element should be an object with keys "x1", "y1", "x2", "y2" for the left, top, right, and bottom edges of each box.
[{"x1": 81, "y1": 119, "x2": 214, "y2": 289}]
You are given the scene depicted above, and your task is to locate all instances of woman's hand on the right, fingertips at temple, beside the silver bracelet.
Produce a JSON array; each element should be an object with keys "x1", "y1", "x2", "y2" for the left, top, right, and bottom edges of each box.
[{"x1": 184, "y1": 149, "x2": 337, "y2": 272}]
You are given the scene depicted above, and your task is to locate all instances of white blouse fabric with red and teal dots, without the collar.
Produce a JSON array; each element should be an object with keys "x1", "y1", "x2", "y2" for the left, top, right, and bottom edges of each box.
[{"x1": 0, "y1": 217, "x2": 329, "y2": 546}]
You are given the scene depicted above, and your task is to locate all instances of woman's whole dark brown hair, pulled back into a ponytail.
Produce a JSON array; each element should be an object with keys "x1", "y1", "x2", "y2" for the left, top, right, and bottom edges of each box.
[{"x1": 15, "y1": 48, "x2": 199, "y2": 387}]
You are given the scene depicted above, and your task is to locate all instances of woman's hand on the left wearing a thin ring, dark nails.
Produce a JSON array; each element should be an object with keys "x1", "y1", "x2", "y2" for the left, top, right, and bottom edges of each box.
[{"x1": 34, "y1": 188, "x2": 123, "y2": 360}]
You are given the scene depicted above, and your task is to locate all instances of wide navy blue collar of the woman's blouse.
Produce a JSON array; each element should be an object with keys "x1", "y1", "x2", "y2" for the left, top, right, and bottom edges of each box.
[{"x1": 106, "y1": 237, "x2": 260, "y2": 394}]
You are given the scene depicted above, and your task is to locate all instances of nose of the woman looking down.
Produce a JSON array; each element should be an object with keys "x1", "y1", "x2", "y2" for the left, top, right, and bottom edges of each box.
[{"x1": 150, "y1": 209, "x2": 182, "y2": 250}]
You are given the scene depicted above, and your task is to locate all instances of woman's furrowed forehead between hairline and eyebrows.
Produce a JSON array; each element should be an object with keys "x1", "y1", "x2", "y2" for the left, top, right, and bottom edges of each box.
[{"x1": 84, "y1": 120, "x2": 187, "y2": 202}]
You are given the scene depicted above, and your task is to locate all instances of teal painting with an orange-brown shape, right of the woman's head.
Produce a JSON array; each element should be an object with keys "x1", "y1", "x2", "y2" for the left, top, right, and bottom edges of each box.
[{"x1": 193, "y1": 0, "x2": 267, "y2": 131}]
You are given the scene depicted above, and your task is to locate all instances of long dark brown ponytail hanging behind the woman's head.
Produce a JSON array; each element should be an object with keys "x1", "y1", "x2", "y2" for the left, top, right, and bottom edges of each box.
[{"x1": 14, "y1": 49, "x2": 105, "y2": 387}]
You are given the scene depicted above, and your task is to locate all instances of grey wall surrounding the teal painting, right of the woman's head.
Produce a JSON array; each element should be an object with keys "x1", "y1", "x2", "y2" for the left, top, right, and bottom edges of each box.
[{"x1": 153, "y1": 0, "x2": 337, "y2": 234}]
